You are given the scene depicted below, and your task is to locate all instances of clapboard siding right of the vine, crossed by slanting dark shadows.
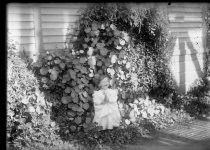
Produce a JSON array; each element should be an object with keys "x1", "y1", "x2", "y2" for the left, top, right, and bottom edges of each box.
[{"x1": 168, "y1": 3, "x2": 206, "y2": 92}]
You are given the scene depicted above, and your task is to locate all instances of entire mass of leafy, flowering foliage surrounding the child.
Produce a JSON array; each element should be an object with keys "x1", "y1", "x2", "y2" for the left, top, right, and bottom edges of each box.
[{"x1": 8, "y1": 4, "x2": 208, "y2": 149}]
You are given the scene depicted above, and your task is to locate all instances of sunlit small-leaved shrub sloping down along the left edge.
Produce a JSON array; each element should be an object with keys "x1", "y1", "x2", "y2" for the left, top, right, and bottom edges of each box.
[{"x1": 7, "y1": 39, "x2": 77, "y2": 149}]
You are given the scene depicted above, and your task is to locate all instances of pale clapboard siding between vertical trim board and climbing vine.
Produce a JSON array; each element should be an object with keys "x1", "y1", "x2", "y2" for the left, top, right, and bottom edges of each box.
[{"x1": 40, "y1": 3, "x2": 85, "y2": 51}]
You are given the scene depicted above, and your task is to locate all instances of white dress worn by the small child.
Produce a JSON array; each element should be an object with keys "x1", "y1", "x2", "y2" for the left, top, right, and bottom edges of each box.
[{"x1": 93, "y1": 89, "x2": 121, "y2": 130}]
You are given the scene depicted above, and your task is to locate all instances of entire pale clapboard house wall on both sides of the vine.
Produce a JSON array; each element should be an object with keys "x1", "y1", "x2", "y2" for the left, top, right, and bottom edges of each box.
[{"x1": 7, "y1": 3, "x2": 206, "y2": 92}]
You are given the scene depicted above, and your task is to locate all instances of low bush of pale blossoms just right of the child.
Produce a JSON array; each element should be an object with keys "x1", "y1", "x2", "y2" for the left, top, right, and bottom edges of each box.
[{"x1": 121, "y1": 97, "x2": 191, "y2": 129}]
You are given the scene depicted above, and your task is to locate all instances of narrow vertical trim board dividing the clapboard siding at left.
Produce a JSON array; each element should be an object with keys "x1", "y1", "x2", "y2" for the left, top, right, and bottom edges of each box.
[{"x1": 34, "y1": 4, "x2": 43, "y2": 58}]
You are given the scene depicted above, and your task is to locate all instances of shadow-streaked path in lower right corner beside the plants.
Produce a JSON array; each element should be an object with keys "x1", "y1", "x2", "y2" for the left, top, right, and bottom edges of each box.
[{"x1": 125, "y1": 119, "x2": 210, "y2": 150}]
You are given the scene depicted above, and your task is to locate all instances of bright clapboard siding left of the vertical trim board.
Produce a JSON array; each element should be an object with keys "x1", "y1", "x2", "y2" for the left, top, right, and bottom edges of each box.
[{"x1": 7, "y1": 4, "x2": 36, "y2": 53}]
